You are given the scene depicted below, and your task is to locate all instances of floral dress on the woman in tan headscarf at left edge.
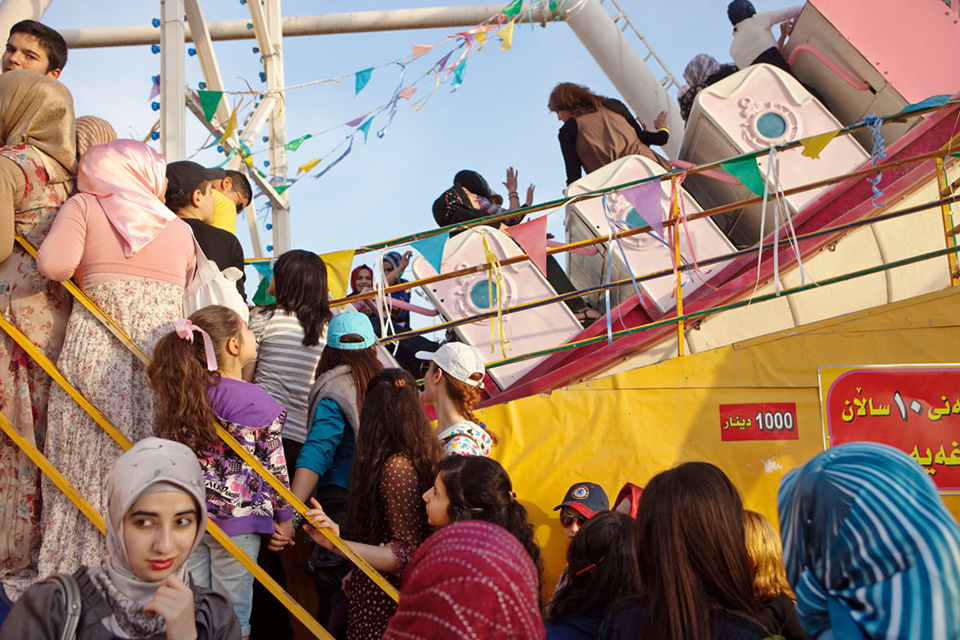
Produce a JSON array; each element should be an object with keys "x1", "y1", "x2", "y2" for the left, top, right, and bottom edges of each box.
[{"x1": 0, "y1": 146, "x2": 73, "y2": 598}]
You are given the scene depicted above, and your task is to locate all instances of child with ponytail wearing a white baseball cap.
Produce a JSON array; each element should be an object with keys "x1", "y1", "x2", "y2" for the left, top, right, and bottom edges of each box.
[{"x1": 417, "y1": 342, "x2": 495, "y2": 456}]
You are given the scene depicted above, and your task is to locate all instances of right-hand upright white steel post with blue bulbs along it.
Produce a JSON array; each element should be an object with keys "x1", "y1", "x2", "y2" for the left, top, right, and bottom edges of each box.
[{"x1": 263, "y1": 0, "x2": 290, "y2": 256}]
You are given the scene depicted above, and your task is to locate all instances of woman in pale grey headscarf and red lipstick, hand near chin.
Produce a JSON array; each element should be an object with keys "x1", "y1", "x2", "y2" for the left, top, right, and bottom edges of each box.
[{"x1": 0, "y1": 438, "x2": 240, "y2": 640}]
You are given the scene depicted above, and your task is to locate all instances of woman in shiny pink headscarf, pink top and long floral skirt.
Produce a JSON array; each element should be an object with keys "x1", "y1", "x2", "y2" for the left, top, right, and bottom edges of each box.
[{"x1": 37, "y1": 140, "x2": 195, "y2": 576}]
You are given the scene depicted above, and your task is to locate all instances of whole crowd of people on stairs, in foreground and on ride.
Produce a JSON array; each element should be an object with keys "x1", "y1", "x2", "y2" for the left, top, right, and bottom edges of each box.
[{"x1": 0, "y1": 7, "x2": 960, "y2": 640}]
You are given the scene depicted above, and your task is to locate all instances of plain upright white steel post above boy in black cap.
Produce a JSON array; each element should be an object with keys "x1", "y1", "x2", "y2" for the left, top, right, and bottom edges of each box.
[{"x1": 160, "y1": 0, "x2": 187, "y2": 162}]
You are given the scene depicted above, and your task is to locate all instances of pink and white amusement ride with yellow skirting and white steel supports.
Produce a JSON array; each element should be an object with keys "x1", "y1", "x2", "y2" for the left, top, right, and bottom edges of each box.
[{"x1": 0, "y1": 0, "x2": 960, "y2": 632}]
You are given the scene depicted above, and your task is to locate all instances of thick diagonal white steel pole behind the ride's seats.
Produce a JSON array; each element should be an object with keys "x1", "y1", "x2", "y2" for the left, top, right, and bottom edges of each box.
[{"x1": 564, "y1": 0, "x2": 684, "y2": 158}]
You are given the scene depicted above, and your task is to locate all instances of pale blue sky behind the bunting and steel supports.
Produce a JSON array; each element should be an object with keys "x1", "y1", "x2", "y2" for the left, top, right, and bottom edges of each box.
[{"x1": 42, "y1": 0, "x2": 795, "y2": 300}]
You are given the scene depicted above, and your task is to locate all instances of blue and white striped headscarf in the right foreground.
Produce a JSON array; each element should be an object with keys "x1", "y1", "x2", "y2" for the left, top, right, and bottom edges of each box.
[{"x1": 777, "y1": 442, "x2": 960, "y2": 639}]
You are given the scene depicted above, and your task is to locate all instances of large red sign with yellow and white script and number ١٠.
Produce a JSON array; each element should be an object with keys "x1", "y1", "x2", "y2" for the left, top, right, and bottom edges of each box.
[{"x1": 820, "y1": 366, "x2": 960, "y2": 491}]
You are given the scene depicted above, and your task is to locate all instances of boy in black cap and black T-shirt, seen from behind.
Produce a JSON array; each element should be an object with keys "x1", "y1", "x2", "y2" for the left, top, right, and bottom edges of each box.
[{"x1": 166, "y1": 160, "x2": 247, "y2": 302}]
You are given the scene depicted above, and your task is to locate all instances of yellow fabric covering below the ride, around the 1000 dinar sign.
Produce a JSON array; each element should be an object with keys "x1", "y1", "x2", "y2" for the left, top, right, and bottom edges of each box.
[{"x1": 477, "y1": 289, "x2": 960, "y2": 592}]
